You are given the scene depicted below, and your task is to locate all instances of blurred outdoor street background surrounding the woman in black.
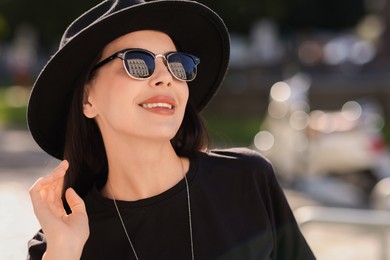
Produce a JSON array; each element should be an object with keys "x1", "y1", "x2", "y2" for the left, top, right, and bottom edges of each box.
[{"x1": 0, "y1": 0, "x2": 390, "y2": 260}]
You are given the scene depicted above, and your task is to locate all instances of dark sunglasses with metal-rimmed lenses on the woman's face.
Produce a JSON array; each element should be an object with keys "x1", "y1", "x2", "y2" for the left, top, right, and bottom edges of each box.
[{"x1": 91, "y1": 49, "x2": 200, "y2": 82}]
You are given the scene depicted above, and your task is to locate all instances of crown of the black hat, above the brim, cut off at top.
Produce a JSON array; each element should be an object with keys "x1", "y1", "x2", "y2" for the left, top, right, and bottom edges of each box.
[{"x1": 59, "y1": 0, "x2": 145, "y2": 49}]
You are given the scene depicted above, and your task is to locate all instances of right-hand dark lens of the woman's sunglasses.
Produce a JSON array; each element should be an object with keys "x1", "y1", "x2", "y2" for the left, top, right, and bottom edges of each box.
[{"x1": 168, "y1": 53, "x2": 199, "y2": 81}]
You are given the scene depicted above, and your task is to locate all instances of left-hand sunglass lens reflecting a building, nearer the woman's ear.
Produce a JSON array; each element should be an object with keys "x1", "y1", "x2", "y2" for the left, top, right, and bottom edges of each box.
[{"x1": 124, "y1": 51, "x2": 155, "y2": 79}]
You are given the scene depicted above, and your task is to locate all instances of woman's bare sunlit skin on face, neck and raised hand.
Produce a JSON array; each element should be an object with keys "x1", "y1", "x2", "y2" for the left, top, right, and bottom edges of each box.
[{"x1": 30, "y1": 31, "x2": 189, "y2": 260}]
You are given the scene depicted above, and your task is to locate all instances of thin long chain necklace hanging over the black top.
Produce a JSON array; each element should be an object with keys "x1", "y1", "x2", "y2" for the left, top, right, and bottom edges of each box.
[{"x1": 108, "y1": 159, "x2": 195, "y2": 260}]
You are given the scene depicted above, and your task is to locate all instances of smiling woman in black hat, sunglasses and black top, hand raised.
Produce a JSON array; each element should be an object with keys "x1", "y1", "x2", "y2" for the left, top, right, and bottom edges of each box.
[{"x1": 28, "y1": 0, "x2": 314, "y2": 259}]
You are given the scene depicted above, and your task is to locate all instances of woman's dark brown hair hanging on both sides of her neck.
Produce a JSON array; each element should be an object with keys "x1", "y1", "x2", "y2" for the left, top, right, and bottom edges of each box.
[{"x1": 63, "y1": 60, "x2": 209, "y2": 201}]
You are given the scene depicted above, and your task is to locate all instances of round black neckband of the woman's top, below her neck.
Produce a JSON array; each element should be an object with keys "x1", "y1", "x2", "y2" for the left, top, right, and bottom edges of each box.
[{"x1": 89, "y1": 156, "x2": 198, "y2": 208}]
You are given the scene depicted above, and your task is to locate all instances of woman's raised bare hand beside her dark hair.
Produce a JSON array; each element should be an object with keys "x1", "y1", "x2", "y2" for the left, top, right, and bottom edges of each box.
[{"x1": 29, "y1": 160, "x2": 89, "y2": 259}]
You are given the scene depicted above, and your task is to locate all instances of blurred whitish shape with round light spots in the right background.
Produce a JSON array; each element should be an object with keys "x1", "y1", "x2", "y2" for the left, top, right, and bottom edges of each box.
[{"x1": 253, "y1": 74, "x2": 390, "y2": 205}]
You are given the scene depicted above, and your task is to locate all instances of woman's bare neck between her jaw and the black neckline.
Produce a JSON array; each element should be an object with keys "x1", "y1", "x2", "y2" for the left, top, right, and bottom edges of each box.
[{"x1": 102, "y1": 135, "x2": 189, "y2": 201}]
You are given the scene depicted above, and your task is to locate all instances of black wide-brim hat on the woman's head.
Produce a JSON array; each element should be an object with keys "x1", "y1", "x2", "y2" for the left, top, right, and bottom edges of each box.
[{"x1": 27, "y1": 0, "x2": 230, "y2": 159}]
